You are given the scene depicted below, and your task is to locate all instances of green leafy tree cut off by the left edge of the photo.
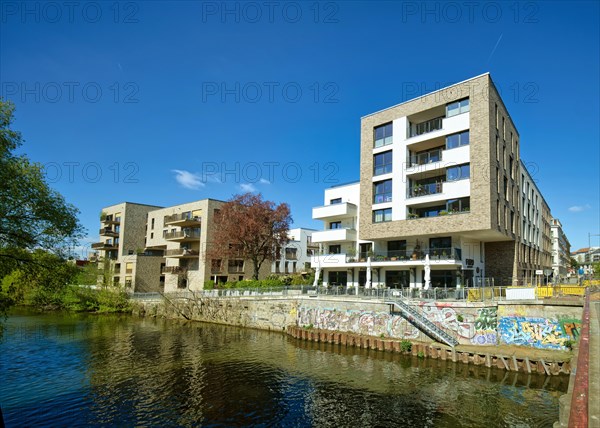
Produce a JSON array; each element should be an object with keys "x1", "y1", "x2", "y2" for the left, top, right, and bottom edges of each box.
[{"x1": 0, "y1": 99, "x2": 84, "y2": 328}]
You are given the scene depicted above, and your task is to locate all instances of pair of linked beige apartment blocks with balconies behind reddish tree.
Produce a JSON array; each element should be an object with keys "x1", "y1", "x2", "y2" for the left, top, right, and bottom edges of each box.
[{"x1": 92, "y1": 199, "x2": 270, "y2": 292}]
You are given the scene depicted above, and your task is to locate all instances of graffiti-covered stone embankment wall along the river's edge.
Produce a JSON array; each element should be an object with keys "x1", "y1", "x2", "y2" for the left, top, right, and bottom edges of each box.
[{"x1": 136, "y1": 296, "x2": 581, "y2": 375}]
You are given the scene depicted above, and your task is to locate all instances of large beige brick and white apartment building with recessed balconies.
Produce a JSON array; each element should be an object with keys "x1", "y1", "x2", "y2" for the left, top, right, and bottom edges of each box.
[{"x1": 312, "y1": 73, "x2": 551, "y2": 287}]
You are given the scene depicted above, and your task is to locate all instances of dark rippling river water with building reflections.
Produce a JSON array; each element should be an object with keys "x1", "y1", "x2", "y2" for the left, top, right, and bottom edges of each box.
[{"x1": 0, "y1": 312, "x2": 568, "y2": 428}]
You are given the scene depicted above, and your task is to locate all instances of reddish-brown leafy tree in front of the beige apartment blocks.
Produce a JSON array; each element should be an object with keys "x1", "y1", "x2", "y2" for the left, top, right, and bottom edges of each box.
[{"x1": 207, "y1": 193, "x2": 292, "y2": 279}]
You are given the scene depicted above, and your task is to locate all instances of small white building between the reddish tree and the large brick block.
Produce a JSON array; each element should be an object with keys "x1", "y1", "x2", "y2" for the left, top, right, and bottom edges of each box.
[{"x1": 271, "y1": 227, "x2": 319, "y2": 275}]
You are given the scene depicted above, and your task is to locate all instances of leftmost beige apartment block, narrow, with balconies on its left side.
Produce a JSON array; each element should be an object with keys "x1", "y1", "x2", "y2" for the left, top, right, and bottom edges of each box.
[{"x1": 92, "y1": 202, "x2": 162, "y2": 291}]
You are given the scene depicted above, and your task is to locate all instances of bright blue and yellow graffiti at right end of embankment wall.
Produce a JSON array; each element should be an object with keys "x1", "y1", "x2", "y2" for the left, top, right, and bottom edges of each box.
[{"x1": 498, "y1": 317, "x2": 570, "y2": 349}]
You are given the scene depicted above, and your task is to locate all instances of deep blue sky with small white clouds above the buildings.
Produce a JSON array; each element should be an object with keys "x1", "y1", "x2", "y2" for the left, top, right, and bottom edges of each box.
[{"x1": 0, "y1": 1, "x2": 600, "y2": 254}]
